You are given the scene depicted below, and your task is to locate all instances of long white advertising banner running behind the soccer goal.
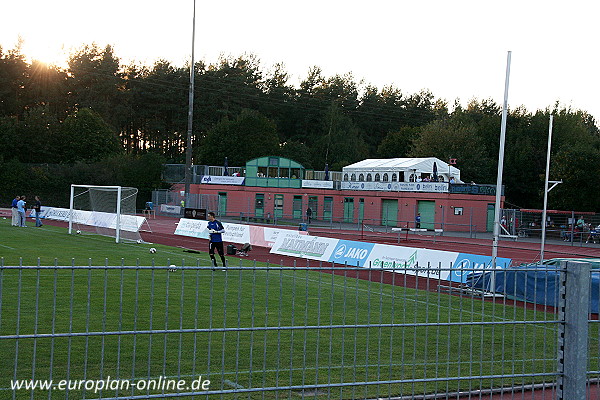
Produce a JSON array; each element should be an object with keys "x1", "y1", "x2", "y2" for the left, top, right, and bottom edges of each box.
[{"x1": 43, "y1": 207, "x2": 146, "y2": 232}]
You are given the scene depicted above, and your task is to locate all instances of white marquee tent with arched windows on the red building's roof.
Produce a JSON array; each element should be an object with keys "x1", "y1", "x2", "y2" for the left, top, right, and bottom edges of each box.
[{"x1": 342, "y1": 157, "x2": 462, "y2": 183}]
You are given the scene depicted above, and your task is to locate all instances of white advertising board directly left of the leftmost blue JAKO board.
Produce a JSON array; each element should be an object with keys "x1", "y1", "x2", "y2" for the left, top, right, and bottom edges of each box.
[{"x1": 271, "y1": 233, "x2": 339, "y2": 261}]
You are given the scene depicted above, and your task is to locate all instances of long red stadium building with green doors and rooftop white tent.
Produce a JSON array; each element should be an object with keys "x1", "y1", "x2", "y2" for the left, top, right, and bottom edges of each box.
[{"x1": 165, "y1": 157, "x2": 504, "y2": 232}]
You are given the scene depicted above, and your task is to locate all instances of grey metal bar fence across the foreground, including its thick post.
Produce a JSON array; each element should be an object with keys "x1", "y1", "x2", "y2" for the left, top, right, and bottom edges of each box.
[{"x1": 0, "y1": 258, "x2": 600, "y2": 400}]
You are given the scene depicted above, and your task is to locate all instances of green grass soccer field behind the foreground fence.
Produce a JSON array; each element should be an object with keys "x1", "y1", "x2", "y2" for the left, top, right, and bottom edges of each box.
[{"x1": 0, "y1": 220, "x2": 576, "y2": 399}]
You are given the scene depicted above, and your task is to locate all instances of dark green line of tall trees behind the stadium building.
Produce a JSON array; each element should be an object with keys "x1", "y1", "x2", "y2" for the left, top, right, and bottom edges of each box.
[{"x1": 0, "y1": 44, "x2": 600, "y2": 211}]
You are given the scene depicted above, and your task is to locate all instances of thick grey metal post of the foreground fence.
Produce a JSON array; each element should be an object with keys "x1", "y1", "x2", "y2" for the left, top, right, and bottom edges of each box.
[{"x1": 556, "y1": 262, "x2": 591, "y2": 400}]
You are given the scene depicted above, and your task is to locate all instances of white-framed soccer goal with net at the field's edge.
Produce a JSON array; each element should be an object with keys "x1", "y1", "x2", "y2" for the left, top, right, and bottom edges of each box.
[{"x1": 69, "y1": 185, "x2": 145, "y2": 243}]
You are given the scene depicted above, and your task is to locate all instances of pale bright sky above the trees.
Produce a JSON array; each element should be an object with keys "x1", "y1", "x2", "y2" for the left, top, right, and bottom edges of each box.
[{"x1": 0, "y1": 0, "x2": 600, "y2": 123}]
